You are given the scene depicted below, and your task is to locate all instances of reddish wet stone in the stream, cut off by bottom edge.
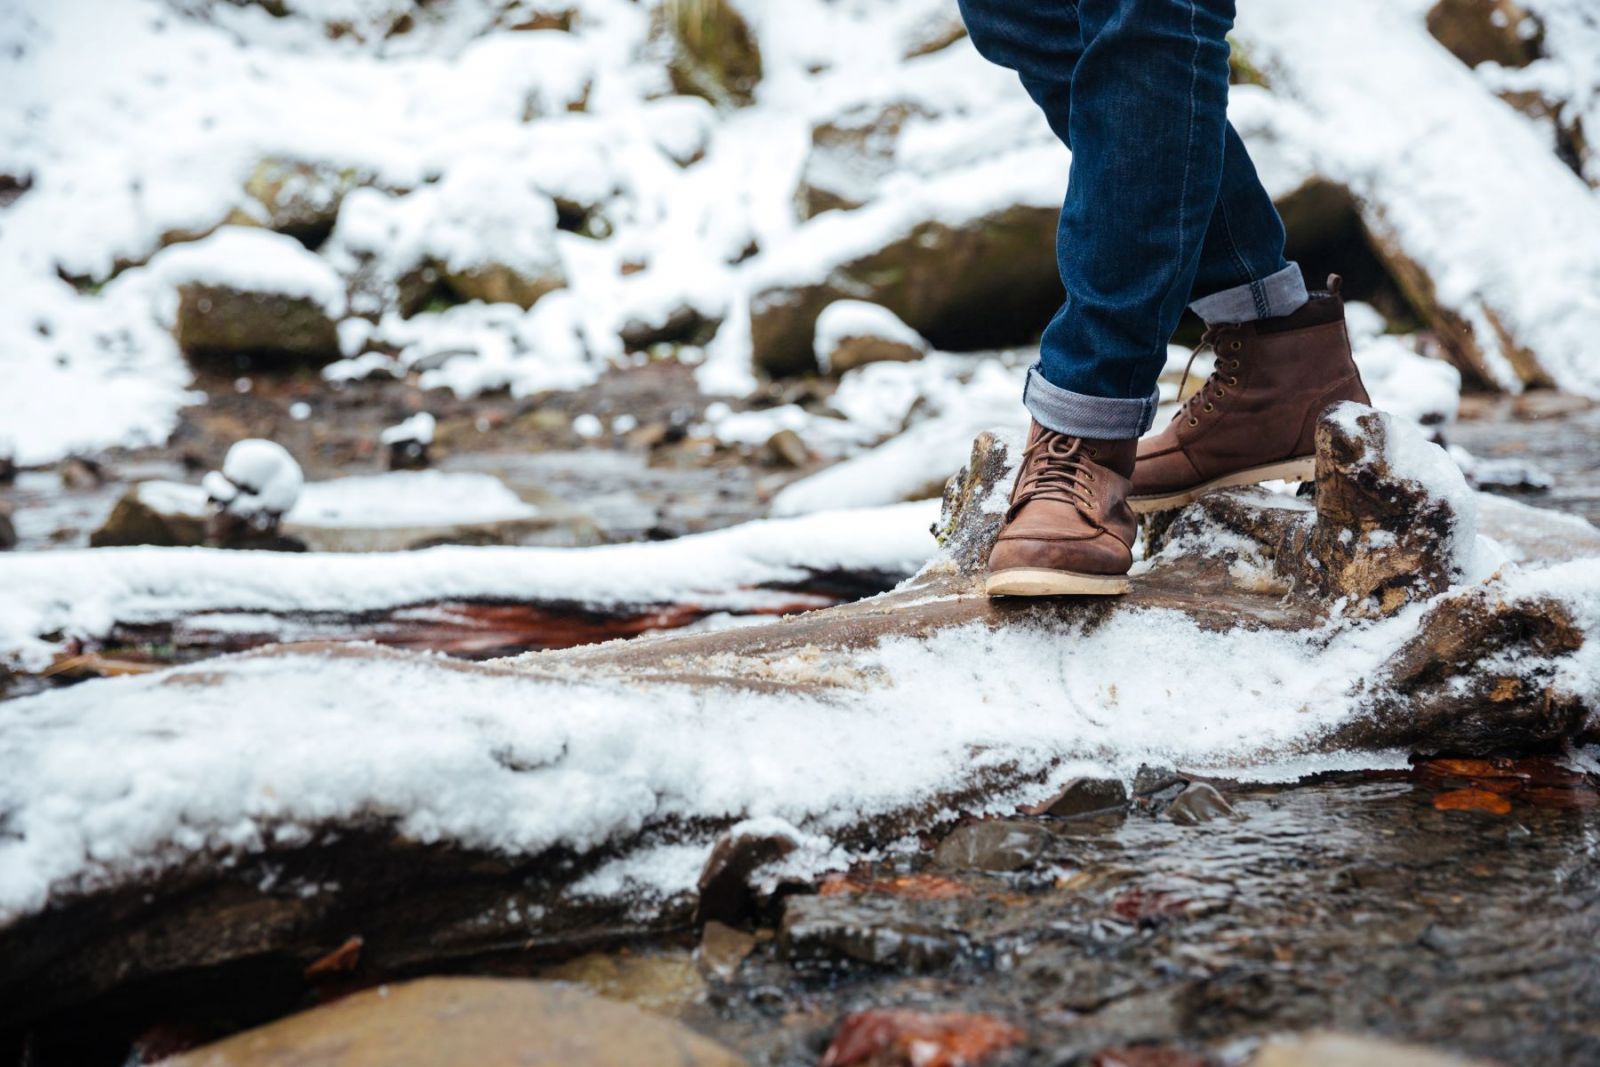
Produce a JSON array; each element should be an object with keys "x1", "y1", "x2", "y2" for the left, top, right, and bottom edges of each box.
[{"x1": 821, "y1": 1009, "x2": 1022, "y2": 1067}]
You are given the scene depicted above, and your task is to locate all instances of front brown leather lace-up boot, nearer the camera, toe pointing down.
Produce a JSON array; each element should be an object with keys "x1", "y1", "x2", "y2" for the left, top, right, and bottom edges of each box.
[{"x1": 984, "y1": 422, "x2": 1139, "y2": 597}]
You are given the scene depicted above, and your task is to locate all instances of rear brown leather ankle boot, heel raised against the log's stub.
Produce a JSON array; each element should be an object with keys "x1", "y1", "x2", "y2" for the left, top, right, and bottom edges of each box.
[{"x1": 1128, "y1": 275, "x2": 1371, "y2": 512}]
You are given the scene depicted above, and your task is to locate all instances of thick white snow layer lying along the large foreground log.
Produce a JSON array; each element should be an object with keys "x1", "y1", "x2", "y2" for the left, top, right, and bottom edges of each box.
[{"x1": 0, "y1": 561, "x2": 1600, "y2": 921}]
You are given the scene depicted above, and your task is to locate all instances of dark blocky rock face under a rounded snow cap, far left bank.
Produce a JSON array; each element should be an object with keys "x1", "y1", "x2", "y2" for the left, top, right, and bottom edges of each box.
[{"x1": 173, "y1": 283, "x2": 339, "y2": 368}]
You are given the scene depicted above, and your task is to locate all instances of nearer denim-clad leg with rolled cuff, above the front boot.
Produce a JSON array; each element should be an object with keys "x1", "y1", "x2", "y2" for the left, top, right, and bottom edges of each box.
[{"x1": 1024, "y1": 0, "x2": 1241, "y2": 438}]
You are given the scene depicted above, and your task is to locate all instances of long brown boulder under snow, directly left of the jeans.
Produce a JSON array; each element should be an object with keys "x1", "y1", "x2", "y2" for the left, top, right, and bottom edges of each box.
[{"x1": 750, "y1": 205, "x2": 1061, "y2": 376}]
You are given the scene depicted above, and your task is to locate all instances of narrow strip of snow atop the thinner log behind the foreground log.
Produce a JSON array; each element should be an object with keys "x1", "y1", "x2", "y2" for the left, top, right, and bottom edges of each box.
[{"x1": 0, "y1": 502, "x2": 938, "y2": 670}]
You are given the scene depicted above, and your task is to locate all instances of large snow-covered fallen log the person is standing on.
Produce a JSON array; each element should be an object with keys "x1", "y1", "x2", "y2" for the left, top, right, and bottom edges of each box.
[{"x1": 0, "y1": 408, "x2": 1600, "y2": 1025}]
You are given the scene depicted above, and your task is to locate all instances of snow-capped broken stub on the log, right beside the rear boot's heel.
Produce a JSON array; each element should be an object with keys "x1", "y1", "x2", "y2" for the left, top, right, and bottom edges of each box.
[{"x1": 1277, "y1": 403, "x2": 1477, "y2": 616}]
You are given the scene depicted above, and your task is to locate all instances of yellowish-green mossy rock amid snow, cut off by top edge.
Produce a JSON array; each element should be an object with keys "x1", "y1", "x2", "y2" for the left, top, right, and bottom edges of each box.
[{"x1": 653, "y1": 0, "x2": 762, "y2": 107}]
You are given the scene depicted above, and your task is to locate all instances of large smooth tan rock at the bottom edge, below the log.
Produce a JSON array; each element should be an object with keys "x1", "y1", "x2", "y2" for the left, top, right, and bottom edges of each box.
[{"x1": 166, "y1": 977, "x2": 744, "y2": 1067}]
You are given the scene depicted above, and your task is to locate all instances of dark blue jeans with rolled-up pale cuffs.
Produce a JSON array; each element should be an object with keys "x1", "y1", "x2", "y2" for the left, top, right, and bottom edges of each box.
[{"x1": 960, "y1": 0, "x2": 1307, "y2": 438}]
